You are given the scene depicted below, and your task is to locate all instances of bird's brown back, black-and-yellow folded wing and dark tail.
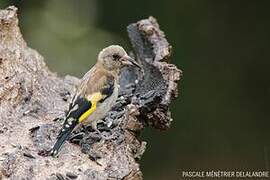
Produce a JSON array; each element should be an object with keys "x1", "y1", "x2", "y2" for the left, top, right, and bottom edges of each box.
[{"x1": 52, "y1": 69, "x2": 115, "y2": 156}]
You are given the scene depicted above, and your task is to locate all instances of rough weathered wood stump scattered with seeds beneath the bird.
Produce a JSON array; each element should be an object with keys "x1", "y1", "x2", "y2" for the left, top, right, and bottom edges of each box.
[{"x1": 0, "y1": 7, "x2": 181, "y2": 180}]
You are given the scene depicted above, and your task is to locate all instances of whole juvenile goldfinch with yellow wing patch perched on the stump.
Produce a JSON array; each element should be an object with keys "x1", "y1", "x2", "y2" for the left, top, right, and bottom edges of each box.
[{"x1": 51, "y1": 45, "x2": 140, "y2": 156}]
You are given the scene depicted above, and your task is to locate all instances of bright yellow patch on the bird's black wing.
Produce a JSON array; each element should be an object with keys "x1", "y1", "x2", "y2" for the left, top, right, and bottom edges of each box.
[{"x1": 79, "y1": 92, "x2": 103, "y2": 123}]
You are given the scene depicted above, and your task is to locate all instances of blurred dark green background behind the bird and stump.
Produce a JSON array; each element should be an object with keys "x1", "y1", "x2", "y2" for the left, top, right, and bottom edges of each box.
[{"x1": 0, "y1": 0, "x2": 270, "y2": 180}]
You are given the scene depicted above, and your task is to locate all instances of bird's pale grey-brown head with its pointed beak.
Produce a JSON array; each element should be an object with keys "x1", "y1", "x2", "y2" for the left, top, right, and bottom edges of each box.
[{"x1": 98, "y1": 45, "x2": 141, "y2": 71}]
